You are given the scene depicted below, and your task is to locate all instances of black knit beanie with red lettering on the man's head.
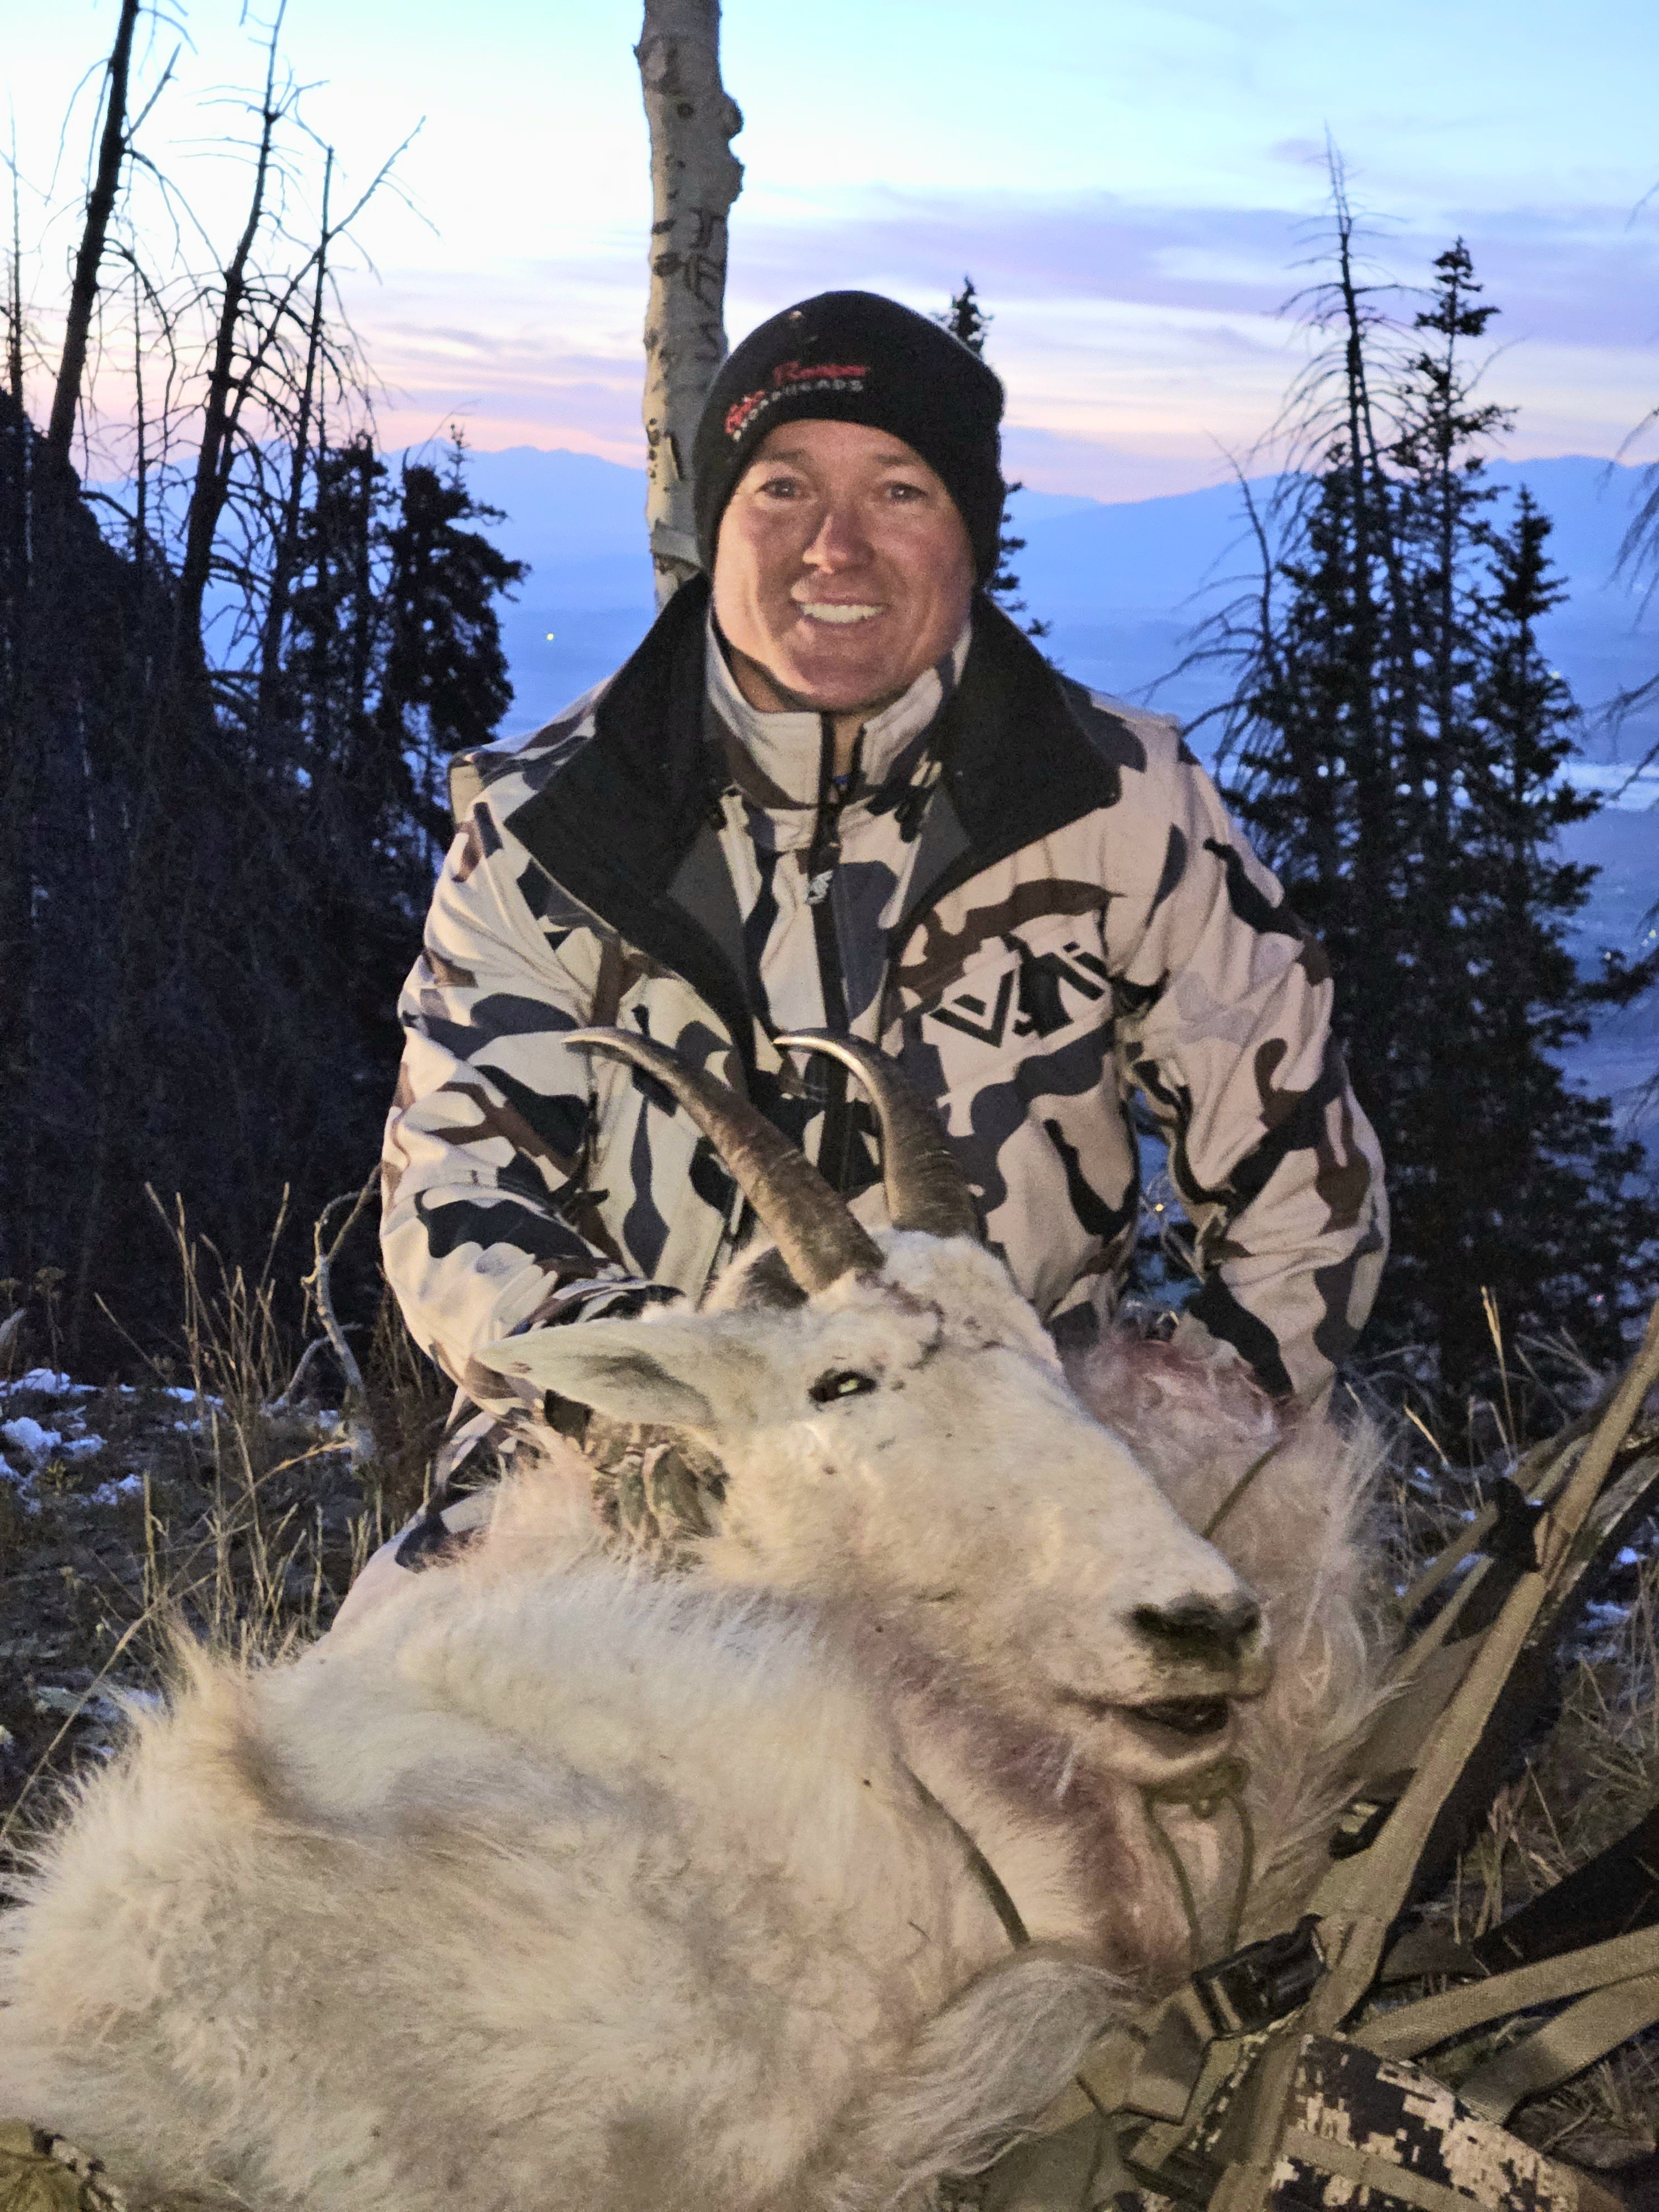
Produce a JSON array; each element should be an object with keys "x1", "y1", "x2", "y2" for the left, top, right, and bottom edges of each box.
[{"x1": 692, "y1": 292, "x2": 1004, "y2": 584}]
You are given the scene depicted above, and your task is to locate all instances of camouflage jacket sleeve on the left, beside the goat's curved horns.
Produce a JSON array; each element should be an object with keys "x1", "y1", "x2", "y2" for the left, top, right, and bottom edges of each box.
[{"x1": 380, "y1": 801, "x2": 646, "y2": 1422}]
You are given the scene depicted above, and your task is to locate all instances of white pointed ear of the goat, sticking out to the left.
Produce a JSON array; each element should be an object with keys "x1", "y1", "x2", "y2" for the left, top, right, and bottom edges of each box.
[{"x1": 478, "y1": 1314, "x2": 754, "y2": 1429}]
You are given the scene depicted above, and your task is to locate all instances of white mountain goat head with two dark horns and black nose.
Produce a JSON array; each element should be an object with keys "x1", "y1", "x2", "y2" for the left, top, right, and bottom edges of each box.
[{"x1": 484, "y1": 1031, "x2": 1270, "y2": 1781}]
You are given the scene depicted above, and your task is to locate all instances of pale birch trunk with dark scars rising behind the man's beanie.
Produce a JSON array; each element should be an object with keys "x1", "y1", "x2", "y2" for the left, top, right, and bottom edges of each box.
[{"x1": 635, "y1": 0, "x2": 743, "y2": 606}]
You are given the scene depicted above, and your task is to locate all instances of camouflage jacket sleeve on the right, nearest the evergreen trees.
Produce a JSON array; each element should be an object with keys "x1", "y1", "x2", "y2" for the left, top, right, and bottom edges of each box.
[{"x1": 1113, "y1": 737, "x2": 1387, "y2": 1396}]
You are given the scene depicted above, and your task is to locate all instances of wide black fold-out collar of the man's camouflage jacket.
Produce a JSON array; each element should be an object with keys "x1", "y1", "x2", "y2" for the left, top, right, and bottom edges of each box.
[{"x1": 507, "y1": 577, "x2": 1141, "y2": 1064}]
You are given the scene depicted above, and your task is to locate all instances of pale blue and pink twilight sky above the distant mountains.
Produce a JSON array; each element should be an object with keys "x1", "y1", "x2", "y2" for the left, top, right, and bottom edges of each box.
[{"x1": 0, "y1": 0, "x2": 1659, "y2": 500}]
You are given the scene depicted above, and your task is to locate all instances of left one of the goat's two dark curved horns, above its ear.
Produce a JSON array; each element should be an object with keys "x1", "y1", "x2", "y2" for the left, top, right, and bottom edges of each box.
[{"x1": 560, "y1": 1029, "x2": 883, "y2": 1294}]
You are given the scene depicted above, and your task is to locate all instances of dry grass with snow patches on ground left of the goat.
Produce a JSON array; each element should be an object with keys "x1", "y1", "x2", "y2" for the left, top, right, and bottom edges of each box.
[{"x1": 0, "y1": 1212, "x2": 451, "y2": 1874}]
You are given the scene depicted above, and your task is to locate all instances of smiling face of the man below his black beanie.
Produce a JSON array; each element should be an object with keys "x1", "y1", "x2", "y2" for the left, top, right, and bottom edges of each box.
[{"x1": 714, "y1": 420, "x2": 973, "y2": 714}]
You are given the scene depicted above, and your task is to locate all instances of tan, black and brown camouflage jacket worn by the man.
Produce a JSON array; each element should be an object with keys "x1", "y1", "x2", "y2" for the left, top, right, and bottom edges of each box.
[{"x1": 383, "y1": 582, "x2": 1385, "y2": 1418}]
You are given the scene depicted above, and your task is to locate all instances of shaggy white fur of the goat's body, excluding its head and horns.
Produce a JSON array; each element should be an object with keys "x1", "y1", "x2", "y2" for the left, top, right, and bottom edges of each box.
[{"x1": 0, "y1": 1343, "x2": 1376, "y2": 2212}]
